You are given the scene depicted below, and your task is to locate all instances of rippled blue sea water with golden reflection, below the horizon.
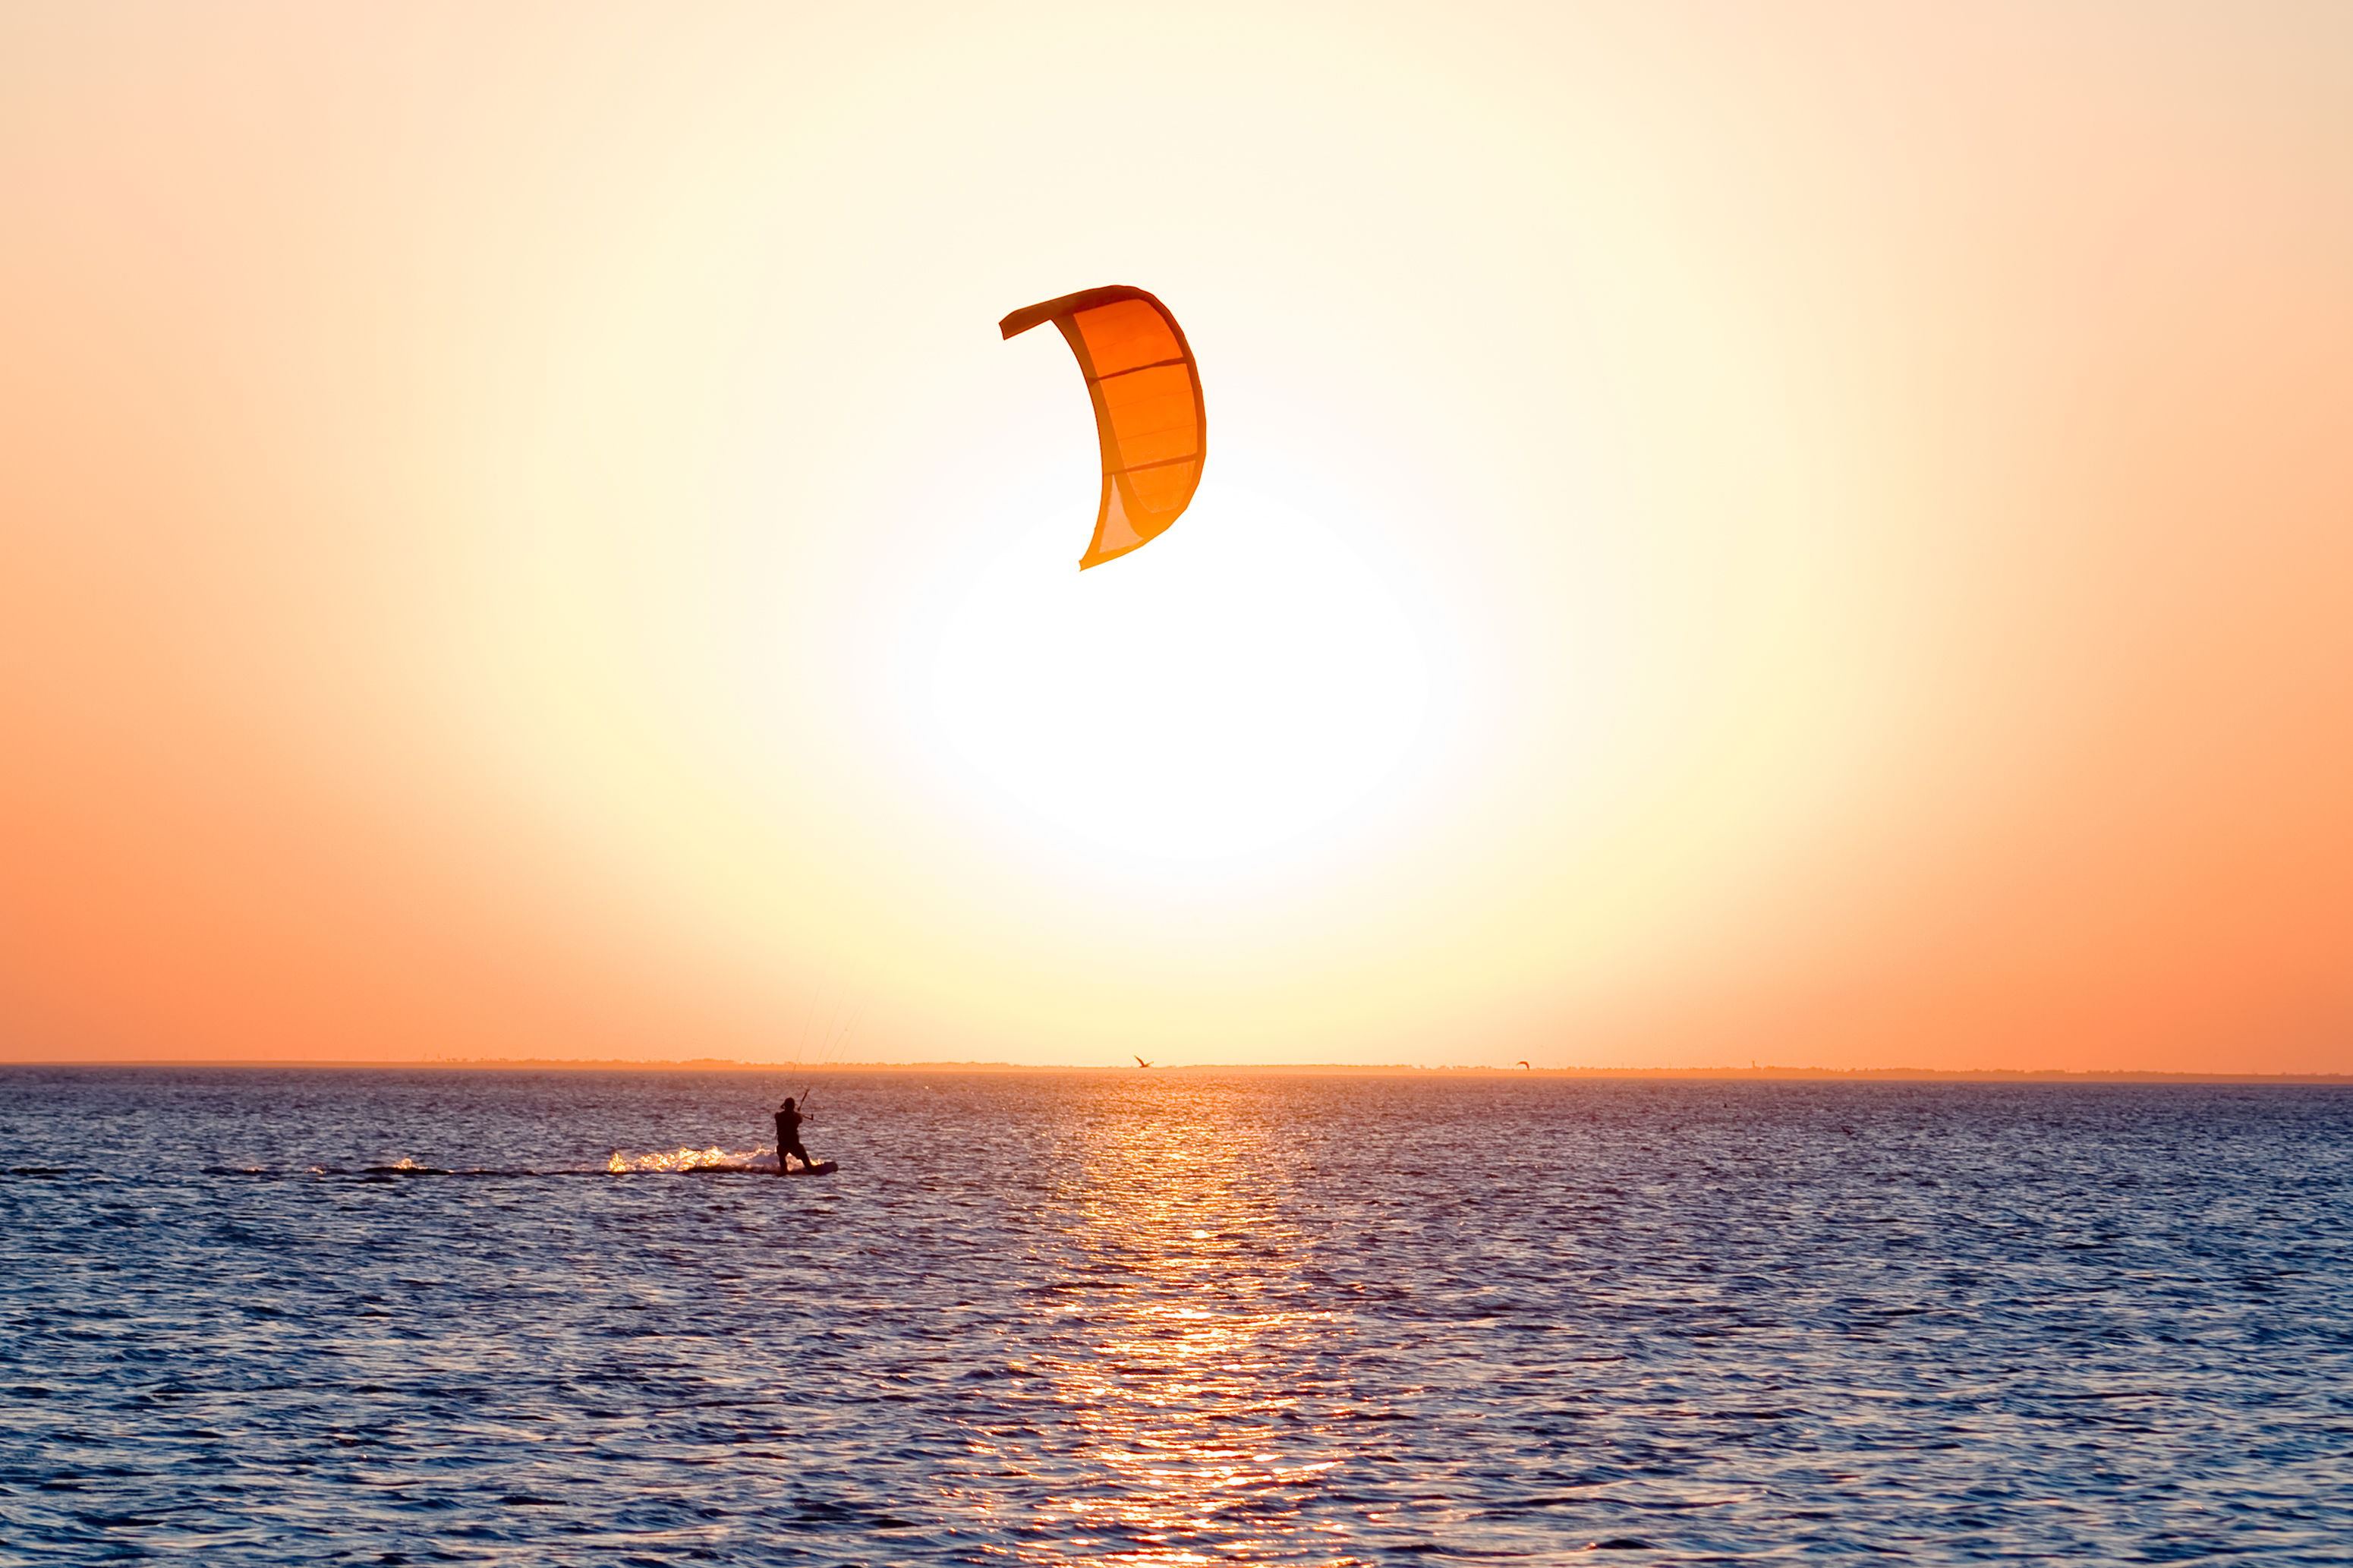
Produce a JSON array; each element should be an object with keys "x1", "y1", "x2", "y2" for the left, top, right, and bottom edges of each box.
[{"x1": 0, "y1": 1069, "x2": 2353, "y2": 1568}]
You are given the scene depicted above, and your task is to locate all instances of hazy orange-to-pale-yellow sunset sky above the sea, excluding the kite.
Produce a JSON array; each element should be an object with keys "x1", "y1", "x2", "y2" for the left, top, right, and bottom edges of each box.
[{"x1": 0, "y1": 0, "x2": 2353, "y2": 1071}]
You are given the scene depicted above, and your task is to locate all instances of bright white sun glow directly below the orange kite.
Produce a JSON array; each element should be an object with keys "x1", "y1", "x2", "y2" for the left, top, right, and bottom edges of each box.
[{"x1": 906, "y1": 475, "x2": 1442, "y2": 874}]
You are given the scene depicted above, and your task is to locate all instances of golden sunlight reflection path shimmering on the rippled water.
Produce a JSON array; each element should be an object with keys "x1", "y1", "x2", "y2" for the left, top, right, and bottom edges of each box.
[{"x1": 967, "y1": 1104, "x2": 1356, "y2": 1568}]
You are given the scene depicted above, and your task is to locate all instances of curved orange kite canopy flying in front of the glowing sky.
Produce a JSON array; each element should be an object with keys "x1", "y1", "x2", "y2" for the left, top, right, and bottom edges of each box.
[{"x1": 997, "y1": 285, "x2": 1207, "y2": 572}]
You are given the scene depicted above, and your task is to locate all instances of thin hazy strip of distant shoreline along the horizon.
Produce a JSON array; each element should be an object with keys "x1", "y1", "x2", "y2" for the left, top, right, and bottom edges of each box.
[{"x1": 0, "y1": 1057, "x2": 2353, "y2": 1085}]
